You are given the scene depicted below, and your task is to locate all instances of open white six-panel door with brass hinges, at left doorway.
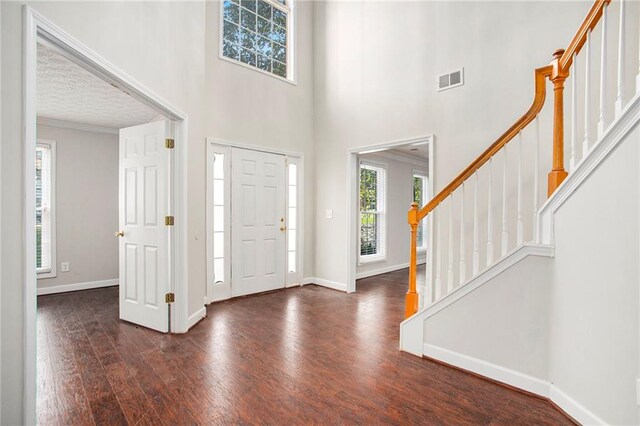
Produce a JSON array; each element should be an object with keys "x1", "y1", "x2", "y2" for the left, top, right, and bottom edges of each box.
[{"x1": 120, "y1": 121, "x2": 170, "y2": 332}]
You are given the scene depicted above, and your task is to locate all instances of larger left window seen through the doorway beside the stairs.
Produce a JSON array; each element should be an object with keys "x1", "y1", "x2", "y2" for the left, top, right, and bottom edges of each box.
[{"x1": 360, "y1": 163, "x2": 386, "y2": 262}]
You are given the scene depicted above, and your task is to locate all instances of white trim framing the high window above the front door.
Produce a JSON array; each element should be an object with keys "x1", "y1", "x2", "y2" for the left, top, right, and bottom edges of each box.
[{"x1": 218, "y1": 0, "x2": 298, "y2": 86}]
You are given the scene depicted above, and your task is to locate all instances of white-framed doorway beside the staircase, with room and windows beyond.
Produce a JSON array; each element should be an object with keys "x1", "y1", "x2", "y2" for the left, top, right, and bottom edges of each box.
[{"x1": 347, "y1": 136, "x2": 434, "y2": 298}]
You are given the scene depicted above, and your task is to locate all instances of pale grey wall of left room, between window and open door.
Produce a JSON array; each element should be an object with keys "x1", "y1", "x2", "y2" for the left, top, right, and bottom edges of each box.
[{"x1": 37, "y1": 125, "x2": 119, "y2": 289}]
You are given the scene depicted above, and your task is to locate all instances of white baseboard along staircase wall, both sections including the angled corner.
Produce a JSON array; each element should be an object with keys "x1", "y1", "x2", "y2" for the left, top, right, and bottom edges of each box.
[{"x1": 423, "y1": 343, "x2": 606, "y2": 425}]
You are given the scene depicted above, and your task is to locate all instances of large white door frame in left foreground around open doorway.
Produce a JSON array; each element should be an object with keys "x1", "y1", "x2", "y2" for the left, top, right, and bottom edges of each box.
[{"x1": 22, "y1": 5, "x2": 188, "y2": 424}]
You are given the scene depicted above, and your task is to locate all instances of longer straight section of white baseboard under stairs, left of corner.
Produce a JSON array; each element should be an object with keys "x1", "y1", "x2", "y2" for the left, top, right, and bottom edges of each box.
[{"x1": 423, "y1": 343, "x2": 549, "y2": 398}]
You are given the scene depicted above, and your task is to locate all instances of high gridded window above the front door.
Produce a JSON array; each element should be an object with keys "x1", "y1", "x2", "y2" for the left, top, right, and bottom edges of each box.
[{"x1": 221, "y1": 0, "x2": 293, "y2": 80}]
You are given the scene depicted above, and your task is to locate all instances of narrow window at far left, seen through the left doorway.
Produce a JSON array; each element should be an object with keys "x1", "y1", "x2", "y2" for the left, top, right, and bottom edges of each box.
[{"x1": 36, "y1": 141, "x2": 56, "y2": 278}]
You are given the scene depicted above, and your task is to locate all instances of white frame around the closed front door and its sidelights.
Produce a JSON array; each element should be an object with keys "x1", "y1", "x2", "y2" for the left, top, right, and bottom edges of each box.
[{"x1": 204, "y1": 137, "x2": 305, "y2": 305}]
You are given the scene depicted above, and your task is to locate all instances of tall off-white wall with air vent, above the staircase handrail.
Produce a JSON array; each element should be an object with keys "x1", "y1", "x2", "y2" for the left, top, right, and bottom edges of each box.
[{"x1": 314, "y1": 1, "x2": 589, "y2": 290}]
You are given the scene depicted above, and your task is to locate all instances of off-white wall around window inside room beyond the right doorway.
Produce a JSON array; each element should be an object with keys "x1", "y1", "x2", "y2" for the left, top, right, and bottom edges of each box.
[{"x1": 356, "y1": 154, "x2": 429, "y2": 277}]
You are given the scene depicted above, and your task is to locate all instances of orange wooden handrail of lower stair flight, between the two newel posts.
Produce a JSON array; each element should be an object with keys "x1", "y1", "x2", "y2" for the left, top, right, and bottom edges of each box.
[{"x1": 409, "y1": 65, "x2": 552, "y2": 225}]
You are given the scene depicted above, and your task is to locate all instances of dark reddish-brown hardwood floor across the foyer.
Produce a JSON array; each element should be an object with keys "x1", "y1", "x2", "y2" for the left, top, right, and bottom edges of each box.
[{"x1": 38, "y1": 270, "x2": 571, "y2": 425}]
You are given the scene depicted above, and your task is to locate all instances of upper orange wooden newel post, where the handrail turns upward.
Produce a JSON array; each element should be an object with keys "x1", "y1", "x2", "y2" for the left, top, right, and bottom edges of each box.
[{"x1": 547, "y1": 49, "x2": 569, "y2": 196}]
